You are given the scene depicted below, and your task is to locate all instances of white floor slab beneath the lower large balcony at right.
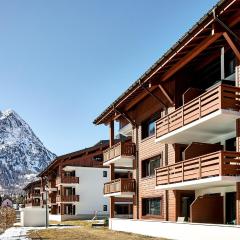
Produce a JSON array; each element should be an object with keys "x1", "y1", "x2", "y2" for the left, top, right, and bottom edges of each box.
[{"x1": 155, "y1": 176, "x2": 240, "y2": 190}]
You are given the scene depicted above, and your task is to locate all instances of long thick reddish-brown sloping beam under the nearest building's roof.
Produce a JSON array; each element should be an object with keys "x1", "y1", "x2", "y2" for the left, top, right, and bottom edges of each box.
[{"x1": 161, "y1": 33, "x2": 223, "y2": 81}]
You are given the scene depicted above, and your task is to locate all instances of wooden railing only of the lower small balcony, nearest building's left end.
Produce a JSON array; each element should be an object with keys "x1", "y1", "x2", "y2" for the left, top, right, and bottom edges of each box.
[{"x1": 103, "y1": 178, "x2": 135, "y2": 194}]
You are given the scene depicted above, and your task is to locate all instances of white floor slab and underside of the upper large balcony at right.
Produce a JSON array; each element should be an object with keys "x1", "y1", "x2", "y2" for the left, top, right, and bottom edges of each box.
[{"x1": 155, "y1": 109, "x2": 240, "y2": 144}]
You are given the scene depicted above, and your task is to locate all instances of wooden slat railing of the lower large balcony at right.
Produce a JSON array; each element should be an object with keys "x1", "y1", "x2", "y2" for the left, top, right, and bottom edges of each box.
[{"x1": 155, "y1": 151, "x2": 240, "y2": 186}]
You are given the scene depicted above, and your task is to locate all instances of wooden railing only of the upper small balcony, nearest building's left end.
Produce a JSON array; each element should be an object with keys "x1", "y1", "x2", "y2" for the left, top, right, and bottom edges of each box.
[{"x1": 103, "y1": 142, "x2": 135, "y2": 162}]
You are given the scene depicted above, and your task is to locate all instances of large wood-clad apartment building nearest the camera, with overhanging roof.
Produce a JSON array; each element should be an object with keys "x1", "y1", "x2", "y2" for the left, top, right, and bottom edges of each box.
[{"x1": 94, "y1": 0, "x2": 240, "y2": 239}]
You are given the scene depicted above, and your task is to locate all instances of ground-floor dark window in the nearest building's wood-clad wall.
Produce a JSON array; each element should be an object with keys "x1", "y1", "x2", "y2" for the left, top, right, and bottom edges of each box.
[{"x1": 142, "y1": 198, "x2": 162, "y2": 216}]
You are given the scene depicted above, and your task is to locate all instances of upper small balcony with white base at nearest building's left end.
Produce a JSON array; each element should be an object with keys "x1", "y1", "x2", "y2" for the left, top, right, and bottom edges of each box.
[{"x1": 103, "y1": 142, "x2": 135, "y2": 167}]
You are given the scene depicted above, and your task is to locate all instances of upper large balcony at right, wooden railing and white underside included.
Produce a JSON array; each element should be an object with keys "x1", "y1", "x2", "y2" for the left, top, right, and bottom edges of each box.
[{"x1": 155, "y1": 84, "x2": 240, "y2": 144}]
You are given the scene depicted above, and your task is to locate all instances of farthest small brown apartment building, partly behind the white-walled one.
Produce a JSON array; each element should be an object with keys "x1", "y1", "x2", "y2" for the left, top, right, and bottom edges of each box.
[{"x1": 23, "y1": 180, "x2": 41, "y2": 207}]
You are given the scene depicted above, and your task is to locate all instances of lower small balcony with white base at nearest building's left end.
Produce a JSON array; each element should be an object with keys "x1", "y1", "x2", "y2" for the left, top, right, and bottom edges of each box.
[{"x1": 103, "y1": 178, "x2": 135, "y2": 198}]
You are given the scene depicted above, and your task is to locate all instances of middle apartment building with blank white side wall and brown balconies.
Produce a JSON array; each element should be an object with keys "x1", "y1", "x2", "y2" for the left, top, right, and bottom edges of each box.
[{"x1": 35, "y1": 140, "x2": 109, "y2": 221}]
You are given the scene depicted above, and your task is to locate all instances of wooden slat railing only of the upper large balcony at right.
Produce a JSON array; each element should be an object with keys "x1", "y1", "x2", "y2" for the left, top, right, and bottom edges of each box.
[{"x1": 156, "y1": 84, "x2": 240, "y2": 138}]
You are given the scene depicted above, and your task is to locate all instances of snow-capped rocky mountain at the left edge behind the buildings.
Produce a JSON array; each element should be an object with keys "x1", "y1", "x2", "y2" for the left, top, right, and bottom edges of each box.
[{"x1": 0, "y1": 110, "x2": 56, "y2": 193}]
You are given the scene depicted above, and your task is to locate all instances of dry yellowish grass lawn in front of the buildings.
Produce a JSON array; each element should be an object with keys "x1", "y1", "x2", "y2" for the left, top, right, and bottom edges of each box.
[{"x1": 28, "y1": 221, "x2": 163, "y2": 240}]
